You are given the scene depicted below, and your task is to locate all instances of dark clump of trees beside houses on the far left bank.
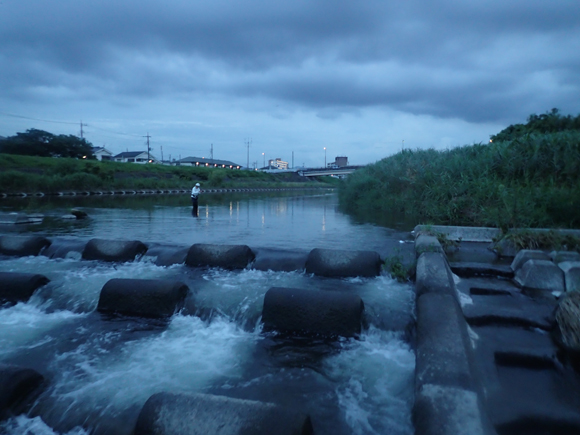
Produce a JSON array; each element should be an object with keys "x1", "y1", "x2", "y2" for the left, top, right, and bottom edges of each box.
[{"x1": 0, "y1": 128, "x2": 95, "y2": 159}]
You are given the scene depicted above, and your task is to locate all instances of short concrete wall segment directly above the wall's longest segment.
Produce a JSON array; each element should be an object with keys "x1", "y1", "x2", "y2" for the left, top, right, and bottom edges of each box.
[{"x1": 415, "y1": 252, "x2": 456, "y2": 297}]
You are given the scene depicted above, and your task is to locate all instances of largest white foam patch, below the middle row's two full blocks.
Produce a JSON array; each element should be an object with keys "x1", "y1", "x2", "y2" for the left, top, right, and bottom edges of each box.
[{"x1": 43, "y1": 315, "x2": 256, "y2": 416}]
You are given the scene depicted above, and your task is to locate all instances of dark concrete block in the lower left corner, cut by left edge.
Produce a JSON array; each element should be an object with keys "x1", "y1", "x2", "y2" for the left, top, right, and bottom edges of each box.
[{"x1": 0, "y1": 364, "x2": 44, "y2": 421}]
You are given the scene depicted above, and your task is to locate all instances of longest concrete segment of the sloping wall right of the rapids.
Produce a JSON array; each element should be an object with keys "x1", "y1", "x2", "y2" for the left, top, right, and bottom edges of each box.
[{"x1": 415, "y1": 293, "x2": 476, "y2": 391}]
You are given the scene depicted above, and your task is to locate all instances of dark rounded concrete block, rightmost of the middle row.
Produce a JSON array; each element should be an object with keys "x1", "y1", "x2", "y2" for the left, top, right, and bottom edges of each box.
[{"x1": 262, "y1": 287, "x2": 364, "y2": 337}]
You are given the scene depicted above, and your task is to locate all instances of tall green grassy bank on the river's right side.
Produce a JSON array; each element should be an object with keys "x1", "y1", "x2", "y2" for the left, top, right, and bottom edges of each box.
[{"x1": 339, "y1": 131, "x2": 580, "y2": 229}]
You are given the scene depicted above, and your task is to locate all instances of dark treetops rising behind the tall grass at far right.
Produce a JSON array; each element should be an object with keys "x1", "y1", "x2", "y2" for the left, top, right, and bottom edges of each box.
[{"x1": 491, "y1": 108, "x2": 580, "y2": 142}]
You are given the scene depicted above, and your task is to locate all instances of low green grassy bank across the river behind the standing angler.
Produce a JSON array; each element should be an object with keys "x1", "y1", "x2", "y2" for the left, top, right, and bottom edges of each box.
[{"x1": 0, "y1": 154, "x2": 337, "y2": 193}]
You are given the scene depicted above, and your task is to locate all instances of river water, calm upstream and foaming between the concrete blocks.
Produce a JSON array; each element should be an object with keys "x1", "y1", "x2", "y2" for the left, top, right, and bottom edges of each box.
[{"x1": 0, "y1": 193, "x2": 415, "y2": 435}]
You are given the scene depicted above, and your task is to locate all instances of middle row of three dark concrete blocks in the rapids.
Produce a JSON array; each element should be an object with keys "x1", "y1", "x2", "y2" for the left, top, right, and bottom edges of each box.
[{"x1": 0, "y1": 272, "x2": 364, "y2": 337}]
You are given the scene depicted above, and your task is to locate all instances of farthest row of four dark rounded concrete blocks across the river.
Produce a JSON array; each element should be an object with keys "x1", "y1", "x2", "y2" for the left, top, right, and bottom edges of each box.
[{"x1": 0, "y1": 235, "x2": 383, "y2": 277}]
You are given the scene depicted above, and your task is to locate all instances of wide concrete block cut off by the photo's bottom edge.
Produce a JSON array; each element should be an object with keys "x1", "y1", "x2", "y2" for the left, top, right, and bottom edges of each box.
[{"x1": 134, "y1": 393, "x2": 314, "y2": 435}]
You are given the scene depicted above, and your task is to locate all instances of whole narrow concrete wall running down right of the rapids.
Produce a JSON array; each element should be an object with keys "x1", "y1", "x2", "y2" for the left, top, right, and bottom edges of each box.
[{"x1": 413, "y1": 234, "x2": 496, "y2": 435}]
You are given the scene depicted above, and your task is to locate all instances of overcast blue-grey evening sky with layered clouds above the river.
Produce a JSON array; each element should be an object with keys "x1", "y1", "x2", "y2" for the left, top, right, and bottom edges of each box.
[{"x1": 0, "y1": 0, "x2": 580, "y2": 166}]
